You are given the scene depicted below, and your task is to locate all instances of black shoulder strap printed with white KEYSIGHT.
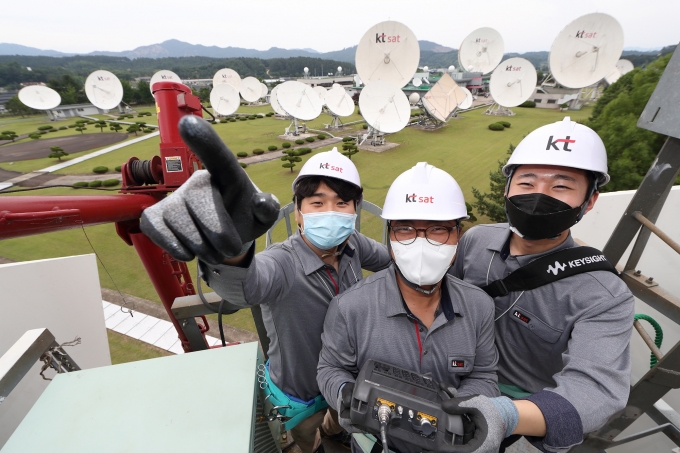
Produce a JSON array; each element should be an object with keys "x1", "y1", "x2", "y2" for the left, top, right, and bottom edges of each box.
[{"x1": 482, "y1": 247, "x2": 619, "y2": 297}]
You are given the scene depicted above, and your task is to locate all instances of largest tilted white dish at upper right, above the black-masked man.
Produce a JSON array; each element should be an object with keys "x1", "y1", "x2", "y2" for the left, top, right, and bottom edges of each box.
[{"x1": 548, "y1": 13, "x2": 623, "y2": 88}]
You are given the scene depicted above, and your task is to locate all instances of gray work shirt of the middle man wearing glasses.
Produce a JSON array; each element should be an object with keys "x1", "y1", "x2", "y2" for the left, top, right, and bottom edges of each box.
[{"x1": 317, "y1": 265, "x2": 500, "y2": 453}]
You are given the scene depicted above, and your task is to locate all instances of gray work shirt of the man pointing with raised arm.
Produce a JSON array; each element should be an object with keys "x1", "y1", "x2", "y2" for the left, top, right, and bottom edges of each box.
[{"x1": 203, "y1": 232, "x2": 391, "y2": 401}]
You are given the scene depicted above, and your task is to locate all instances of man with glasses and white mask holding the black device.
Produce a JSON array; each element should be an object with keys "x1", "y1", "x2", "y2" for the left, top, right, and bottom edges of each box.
[{"x1": 317, "y1": 162, "x2": 499, "y2": 453}]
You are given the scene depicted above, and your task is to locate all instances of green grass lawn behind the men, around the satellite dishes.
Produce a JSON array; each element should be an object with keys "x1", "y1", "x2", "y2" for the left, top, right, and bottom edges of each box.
[{"x1": 0, "y1": 106, "x2": 590, "y2": 331}]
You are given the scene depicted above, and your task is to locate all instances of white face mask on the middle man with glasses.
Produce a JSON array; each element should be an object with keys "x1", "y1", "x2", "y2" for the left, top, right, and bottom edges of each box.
[{"x1": 390, "y1": 238, "x2": 457, "y2": 286}]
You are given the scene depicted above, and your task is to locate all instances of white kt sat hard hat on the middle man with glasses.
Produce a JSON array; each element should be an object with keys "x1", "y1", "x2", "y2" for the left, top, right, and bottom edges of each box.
[{"x1": 382, "y1": 162, "x2": 469, "y2": 220}]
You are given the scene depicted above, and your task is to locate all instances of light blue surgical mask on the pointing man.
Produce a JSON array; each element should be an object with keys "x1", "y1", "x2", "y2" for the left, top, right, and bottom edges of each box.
[{"x1": 301, "y1": 211, "x2": 357, "y2": 250}]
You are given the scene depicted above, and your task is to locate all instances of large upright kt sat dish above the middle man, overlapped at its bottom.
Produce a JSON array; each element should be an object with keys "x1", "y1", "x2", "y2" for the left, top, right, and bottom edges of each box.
[{"x1": 356, "y1": 21, "x2": 420, "y2": 88}]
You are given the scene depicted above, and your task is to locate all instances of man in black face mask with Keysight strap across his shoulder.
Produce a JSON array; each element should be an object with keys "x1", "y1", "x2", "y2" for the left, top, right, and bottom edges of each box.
[{"x1": 447, "y1": 117, "x2": 634, "y2": 452}]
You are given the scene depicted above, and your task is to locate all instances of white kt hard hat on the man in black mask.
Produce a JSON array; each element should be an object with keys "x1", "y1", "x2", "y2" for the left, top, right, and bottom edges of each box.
[{"x1": 503, "y1": 116, "x2": 609, "y2": 186}]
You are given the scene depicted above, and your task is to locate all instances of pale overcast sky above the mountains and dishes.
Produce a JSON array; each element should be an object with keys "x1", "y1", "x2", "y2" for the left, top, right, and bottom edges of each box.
[{"x1": 0, "y1": 0, "x2": 680, "y2": 53}]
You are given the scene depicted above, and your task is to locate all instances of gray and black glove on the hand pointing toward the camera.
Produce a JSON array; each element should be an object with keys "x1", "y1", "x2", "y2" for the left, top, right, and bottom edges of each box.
[{"x1": 140, "y1": 115, "x2": 280, "y2": 265}]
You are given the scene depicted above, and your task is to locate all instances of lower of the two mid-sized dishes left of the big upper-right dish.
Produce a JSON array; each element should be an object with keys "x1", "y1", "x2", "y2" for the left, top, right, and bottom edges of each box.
[{"x1": 489, "y1": 57, "x2": 537, "y2": 107}]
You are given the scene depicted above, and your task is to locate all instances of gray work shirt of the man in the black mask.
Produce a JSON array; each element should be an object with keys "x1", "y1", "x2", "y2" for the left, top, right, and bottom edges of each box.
[{"x1": 449, "y1": 223, "x2": 634, "y2": 451}]
